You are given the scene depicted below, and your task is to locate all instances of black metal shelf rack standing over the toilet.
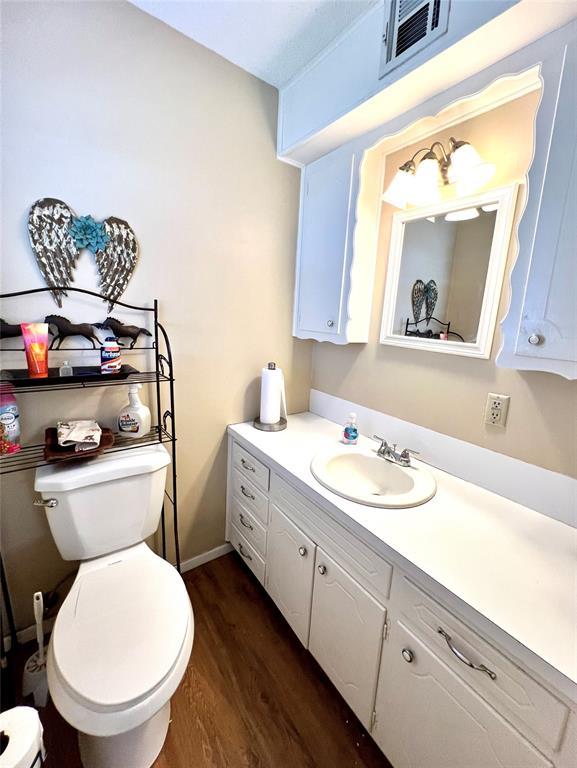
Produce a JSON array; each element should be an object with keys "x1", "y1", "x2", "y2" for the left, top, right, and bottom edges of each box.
[{"x1": 0, "y1": 286, "x2": 180, "y2": 638}]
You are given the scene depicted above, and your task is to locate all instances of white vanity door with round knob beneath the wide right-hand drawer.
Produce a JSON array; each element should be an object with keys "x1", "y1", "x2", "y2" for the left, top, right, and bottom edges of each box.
[{"x1": 372, "y1": 622, "x2": 552, "y2": 768}]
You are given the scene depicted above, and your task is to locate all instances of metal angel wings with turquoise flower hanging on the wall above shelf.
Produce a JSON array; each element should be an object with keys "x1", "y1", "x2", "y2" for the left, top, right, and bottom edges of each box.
[{"x1": 28, "y1": 197, "x2": 138, "y2": 310}]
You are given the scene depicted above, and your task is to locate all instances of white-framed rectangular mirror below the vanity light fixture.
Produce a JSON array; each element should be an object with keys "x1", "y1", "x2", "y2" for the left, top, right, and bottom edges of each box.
[{"x1": 381, "y1": 185, "x2": 517, "y2": 358}]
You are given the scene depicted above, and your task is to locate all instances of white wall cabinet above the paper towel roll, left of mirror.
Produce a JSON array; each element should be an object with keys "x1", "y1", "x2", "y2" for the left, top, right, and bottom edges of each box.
[{"x1": 293, "y1": 149, "x2": 374, "y2": 344}]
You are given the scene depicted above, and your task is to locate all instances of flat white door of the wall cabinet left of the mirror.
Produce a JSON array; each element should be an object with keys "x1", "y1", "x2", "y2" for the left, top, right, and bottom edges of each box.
[{"x1": 296, "y1": 153, "x2": 355, "y2": 335}]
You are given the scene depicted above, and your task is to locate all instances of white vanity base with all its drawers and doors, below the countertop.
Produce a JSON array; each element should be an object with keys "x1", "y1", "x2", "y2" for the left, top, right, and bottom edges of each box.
[{"x1": 227, "y1": 438, "x2": 577, "y2": 768}]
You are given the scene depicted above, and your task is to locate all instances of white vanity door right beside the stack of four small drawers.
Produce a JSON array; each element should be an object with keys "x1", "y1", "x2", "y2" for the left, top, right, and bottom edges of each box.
[{"x1": 265, "y1": 505, "x2": 316, "y2": 646}]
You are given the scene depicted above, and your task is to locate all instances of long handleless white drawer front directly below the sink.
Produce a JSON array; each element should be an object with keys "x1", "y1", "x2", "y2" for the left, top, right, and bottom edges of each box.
[{"x1": 270, "y1": 473, "x2": 393, "y2": 599}]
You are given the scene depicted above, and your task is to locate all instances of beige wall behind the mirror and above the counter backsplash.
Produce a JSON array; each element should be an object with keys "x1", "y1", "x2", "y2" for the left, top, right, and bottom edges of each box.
[{"x1": 313, "y1": 92, "x2": 577, "y2": 476}]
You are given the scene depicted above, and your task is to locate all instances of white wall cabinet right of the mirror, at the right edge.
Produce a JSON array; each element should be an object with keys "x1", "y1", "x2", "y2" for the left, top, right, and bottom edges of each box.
[{"x1": 497, "y1": 40, "x2": 577, "y2": 379}]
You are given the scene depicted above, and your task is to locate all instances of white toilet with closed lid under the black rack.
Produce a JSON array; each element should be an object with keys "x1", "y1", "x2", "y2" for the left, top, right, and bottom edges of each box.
[{"x1": 34, "y1": 445, "x2": 194, "y2": 768}]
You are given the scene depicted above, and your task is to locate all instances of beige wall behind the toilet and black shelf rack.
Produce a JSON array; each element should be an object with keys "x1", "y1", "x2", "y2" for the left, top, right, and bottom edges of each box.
[{"x1": 2, "y1": 2, "x2": 311, "y2": 626}]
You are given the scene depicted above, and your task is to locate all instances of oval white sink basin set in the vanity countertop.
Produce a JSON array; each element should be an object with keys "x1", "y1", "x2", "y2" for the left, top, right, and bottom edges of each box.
[{"x1": 311, "y1": 445, "x2": 437, "y2": 509}]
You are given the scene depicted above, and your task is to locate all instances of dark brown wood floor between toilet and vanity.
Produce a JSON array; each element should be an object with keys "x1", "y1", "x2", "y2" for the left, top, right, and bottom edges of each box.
[{"x1": 7, "y1": 554, "x2": 390, "y2": 768}]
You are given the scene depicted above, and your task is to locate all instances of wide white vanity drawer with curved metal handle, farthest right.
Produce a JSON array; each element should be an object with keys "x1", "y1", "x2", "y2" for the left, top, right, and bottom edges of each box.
[{"x1": 395, "y1": 578, "x2": 569, "y2": 749}]
